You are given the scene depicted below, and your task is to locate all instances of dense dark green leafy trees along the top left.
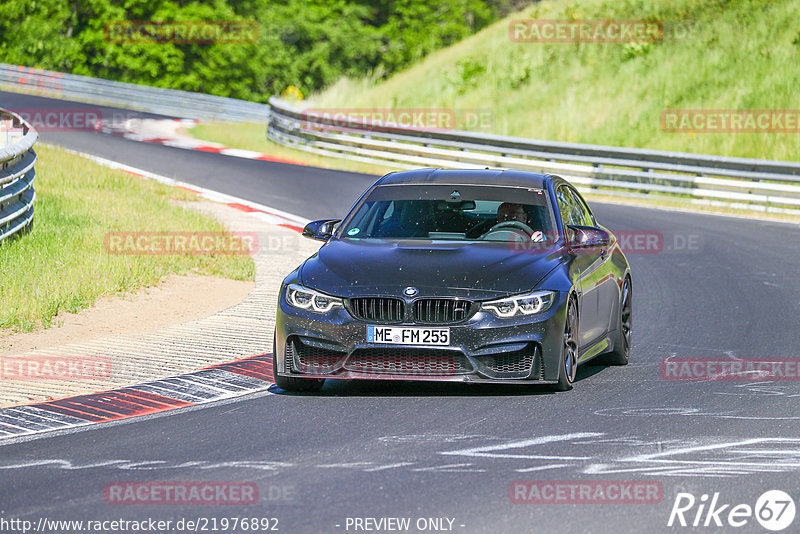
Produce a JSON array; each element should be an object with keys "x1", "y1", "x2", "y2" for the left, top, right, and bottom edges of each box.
[{"x1": 0, "y1": 0, "x2": 514, "y2": 102}]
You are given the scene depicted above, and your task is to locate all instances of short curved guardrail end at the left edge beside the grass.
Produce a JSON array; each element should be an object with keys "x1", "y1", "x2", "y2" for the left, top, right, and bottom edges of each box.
[{"x1": 0, "y1": 108, "x2": 39, "y2": 241}]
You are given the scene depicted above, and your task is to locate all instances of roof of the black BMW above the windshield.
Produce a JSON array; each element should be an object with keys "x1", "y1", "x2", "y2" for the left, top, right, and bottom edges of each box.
[{"x1": 375, "y1": 169, "x2": 549, "y2": 189}]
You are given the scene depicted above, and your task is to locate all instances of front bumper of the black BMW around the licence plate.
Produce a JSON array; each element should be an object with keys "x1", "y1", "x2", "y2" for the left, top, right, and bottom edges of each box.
[{"x1": 274, "y1": 287, "x2": 567, "y2": 384}]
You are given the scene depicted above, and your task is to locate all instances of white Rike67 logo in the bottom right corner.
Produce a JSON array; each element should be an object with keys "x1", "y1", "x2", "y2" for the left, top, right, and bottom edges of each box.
[{"x1": 667, "y1": 490, "x2": 795, "y2": 532}]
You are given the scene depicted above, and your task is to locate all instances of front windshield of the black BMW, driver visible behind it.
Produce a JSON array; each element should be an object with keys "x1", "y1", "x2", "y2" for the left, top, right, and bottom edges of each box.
[{"x1": 339, "y1": 185, "x2": 554, "y2": 242}]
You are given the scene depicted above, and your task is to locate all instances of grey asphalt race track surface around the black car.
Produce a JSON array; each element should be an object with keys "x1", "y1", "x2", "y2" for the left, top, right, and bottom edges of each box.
[{"x1": 0, "y1": 90, "x2": 800, "y2": 533}]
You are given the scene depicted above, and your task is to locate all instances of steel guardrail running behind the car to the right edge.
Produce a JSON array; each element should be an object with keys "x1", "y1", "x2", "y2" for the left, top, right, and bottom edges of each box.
[{"x1": 267, "y1": 97, "x2": 800, "y2": 214}]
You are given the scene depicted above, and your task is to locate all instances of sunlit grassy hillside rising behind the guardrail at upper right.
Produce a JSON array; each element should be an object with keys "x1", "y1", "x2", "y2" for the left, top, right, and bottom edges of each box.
[{"x1": 306, "y1": 0, "x2": 800, "y2": 160}]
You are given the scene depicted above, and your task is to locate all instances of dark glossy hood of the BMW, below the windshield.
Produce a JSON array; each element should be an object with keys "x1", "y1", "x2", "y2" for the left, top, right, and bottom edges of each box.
[{"x1": 300, "y1": 239, "x2": 563, "y2": 299}]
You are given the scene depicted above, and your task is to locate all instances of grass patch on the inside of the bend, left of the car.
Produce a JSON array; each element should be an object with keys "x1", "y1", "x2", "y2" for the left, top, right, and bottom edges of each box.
[{"x1": 0, "y1": 146, "x2": 255, "y2": 333}]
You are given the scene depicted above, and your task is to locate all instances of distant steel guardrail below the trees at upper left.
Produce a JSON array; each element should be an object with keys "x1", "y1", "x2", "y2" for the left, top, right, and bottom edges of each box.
[{"x1": 0, "y1": 63, "x2": 269, "y2": 124}]
